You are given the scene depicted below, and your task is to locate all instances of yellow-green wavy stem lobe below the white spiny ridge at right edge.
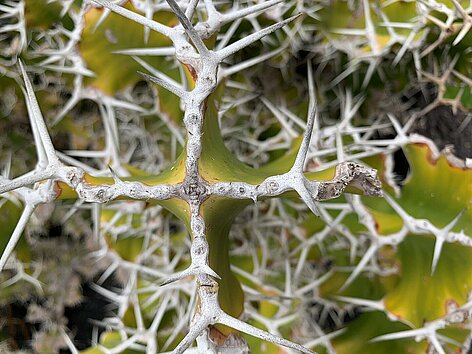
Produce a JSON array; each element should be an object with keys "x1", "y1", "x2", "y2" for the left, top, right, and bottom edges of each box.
[{"x1": 384, "y1": 235, "x2": 472, "y2": 327}]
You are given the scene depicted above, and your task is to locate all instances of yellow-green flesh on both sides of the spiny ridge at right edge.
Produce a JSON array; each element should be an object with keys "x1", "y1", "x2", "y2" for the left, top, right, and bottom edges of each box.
[{"x1": 364, "y1": 143, "x2": 472, "y2": 326}]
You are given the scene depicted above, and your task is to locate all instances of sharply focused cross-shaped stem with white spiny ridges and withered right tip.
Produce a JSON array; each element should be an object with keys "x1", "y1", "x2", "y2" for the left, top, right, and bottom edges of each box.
[{"x1": 0, "y1": 0, "x2": 380, "y2": 353}]
